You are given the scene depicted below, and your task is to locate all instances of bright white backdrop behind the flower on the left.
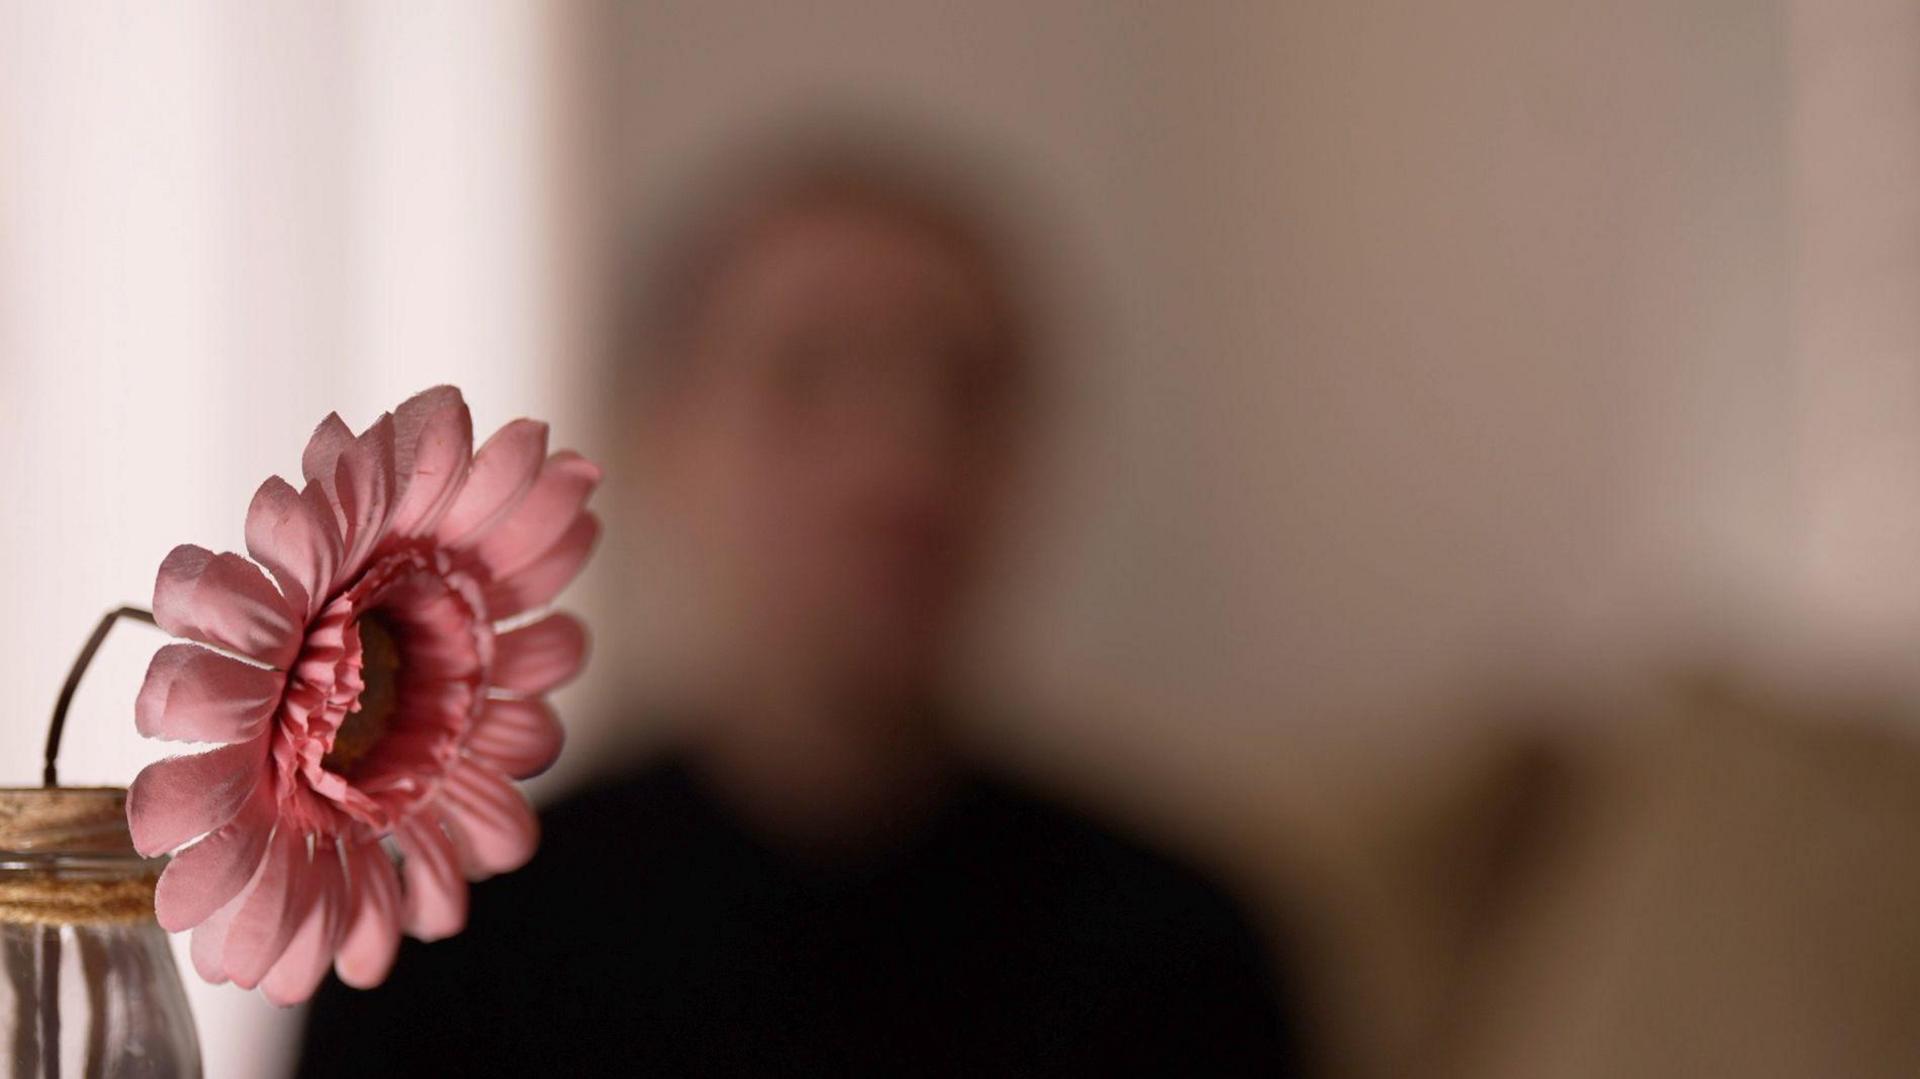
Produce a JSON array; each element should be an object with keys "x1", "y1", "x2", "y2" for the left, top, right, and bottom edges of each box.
[{"x1": 0, "y1": 0, "x2": 572, "y2": 1079}]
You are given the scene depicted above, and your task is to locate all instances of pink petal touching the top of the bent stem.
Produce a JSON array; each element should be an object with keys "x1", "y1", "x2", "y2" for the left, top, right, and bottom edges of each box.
[{"x1": 154, "y1": 543, "x2": 305, "y2": 666}]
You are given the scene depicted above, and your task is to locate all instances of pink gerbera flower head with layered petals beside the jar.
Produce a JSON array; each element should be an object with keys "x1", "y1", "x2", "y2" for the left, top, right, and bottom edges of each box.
[{"x1": 127, "y1": 386, "x2": 599, "y2": 1004}]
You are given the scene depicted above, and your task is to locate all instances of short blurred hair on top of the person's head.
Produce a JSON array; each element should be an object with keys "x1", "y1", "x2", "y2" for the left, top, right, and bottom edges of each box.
[{"x1": 611, "y1": 117, "x2": 1035, "y2": 399}]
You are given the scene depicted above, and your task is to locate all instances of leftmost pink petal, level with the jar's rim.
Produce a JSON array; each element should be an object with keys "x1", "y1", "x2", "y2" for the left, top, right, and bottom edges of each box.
[{"x1": 127, "y1": 737, "x2": 267, "y2": 858}]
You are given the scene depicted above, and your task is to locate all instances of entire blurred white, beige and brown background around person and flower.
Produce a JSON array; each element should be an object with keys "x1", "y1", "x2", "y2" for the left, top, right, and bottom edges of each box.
[{"x1": 0, "y1": 0, "x2": 1920, "y2": 1075}]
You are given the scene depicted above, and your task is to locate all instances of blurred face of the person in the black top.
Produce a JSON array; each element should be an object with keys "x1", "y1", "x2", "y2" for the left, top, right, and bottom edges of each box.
[{"x1": 666, "y1": 196, "x2": 1023, "y2": 691}]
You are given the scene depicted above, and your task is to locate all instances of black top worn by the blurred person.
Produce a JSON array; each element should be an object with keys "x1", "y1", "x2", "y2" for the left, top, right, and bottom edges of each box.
[{"x1": 300, "y1": 752, "x2": 1292, "y2": 1079}]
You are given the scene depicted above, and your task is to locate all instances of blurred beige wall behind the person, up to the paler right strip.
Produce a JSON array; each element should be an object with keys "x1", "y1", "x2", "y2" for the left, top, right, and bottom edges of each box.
[{"x1": 576, "y1": 0, "x2": 1807, "y2": 818}]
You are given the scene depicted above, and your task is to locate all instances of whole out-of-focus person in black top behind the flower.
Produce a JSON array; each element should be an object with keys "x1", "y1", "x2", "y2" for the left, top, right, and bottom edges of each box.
[{"x1": 301, "y1": 121, "x2": 1292, "y2": 1077}]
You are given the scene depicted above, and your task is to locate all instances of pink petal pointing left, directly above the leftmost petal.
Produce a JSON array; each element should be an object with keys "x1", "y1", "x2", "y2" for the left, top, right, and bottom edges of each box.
[{"x1": 132, "y1": 645, "x2": 286, "y2": 743}]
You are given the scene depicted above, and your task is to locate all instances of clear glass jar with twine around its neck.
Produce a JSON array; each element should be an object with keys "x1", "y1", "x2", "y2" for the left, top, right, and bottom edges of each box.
[{"x1": 0, "y1": 787, "x2": 200, "y2": 1079}]
